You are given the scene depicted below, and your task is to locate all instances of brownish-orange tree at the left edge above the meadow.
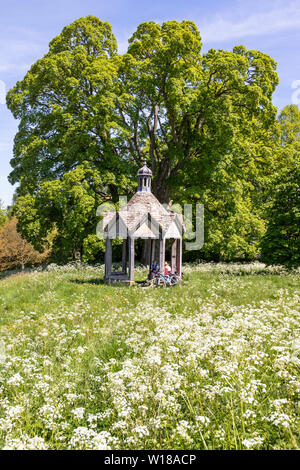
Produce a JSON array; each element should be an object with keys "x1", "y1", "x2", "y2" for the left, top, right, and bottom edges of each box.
[{"x1": 0, "y1": 217, "x2": 48, "y2": 271}]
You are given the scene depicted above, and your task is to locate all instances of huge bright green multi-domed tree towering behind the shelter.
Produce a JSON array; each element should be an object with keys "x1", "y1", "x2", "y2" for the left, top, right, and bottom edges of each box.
[{"x1": 7, "y1": 16, "x2": 279, "y2": 259}]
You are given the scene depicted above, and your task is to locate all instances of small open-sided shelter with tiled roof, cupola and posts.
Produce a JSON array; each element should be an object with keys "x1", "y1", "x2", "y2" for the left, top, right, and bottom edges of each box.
[{"x1": 102, "y1": 162, "x2": 184, "y2": 284}]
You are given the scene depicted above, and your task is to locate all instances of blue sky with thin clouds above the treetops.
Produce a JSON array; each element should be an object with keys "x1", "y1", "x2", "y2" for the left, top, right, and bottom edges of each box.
[{"x1": 0, "y1": 0, "x2": 300, "y2": 205}]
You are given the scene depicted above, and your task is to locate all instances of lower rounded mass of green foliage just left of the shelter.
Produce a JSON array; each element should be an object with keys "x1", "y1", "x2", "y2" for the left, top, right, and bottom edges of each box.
[{"x1": 14, "y1": 163, "x2": 108, "y2": 261}]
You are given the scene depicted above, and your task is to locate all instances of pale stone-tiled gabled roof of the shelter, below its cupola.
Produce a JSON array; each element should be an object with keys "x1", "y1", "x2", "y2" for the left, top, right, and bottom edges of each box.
[{"x1": 103, "y1": 192, "x2": 183, "y2": 237}]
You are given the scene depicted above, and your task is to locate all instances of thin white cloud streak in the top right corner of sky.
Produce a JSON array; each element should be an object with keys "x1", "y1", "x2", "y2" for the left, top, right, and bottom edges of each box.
[{"x1": 198, "y1": 1, "x2": 300, "y2": 42}]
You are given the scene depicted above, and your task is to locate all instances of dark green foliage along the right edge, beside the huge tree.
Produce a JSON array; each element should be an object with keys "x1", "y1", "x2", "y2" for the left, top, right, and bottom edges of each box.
[{"x1": 261, "y1": 105, "x2": 300, "y2": 266}]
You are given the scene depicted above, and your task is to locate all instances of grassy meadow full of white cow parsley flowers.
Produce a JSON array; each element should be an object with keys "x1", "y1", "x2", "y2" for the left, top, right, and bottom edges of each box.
[{"x1": 0, "y1": 263, "x2": 300, "y2": 449}]
